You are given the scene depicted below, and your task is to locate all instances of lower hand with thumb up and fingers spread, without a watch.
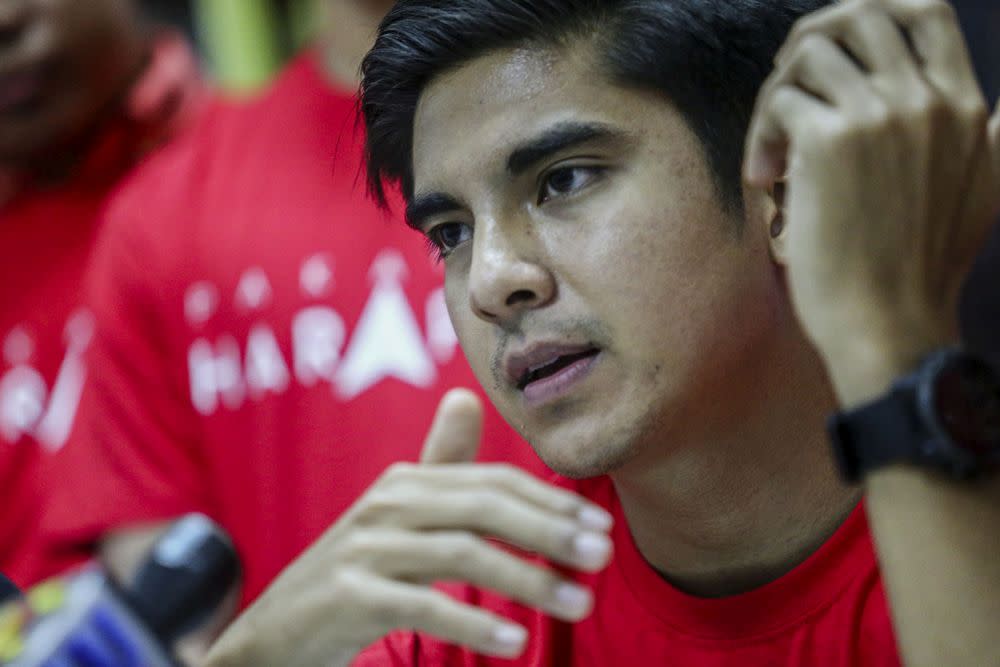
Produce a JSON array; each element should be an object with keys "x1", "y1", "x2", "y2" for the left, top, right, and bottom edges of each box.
[{"x1": 207, "y1": 390, "x2": 611, "y2": 666}]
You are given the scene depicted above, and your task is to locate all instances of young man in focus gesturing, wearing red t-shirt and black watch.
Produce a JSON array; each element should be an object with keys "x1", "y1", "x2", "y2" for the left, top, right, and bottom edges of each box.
[{"x1": 208, "y1": 0, "x2": 1000, "y2": 667}]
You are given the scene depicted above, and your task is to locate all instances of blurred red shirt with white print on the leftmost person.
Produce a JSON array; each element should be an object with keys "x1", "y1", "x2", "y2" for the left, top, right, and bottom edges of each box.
[{"x1": 0, "y1": 35, "x2": 204, "y2": 586}]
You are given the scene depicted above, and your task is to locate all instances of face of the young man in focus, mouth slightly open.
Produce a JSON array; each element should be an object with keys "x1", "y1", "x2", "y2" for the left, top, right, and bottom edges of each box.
[{"x1": 410, "y1": 48, "x2": 781, "y2": 476}]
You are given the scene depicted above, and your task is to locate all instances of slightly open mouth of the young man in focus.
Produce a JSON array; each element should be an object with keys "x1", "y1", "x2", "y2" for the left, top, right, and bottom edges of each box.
[{"x1": 508, "y1": 345, "x2": 601, "y2": 405}]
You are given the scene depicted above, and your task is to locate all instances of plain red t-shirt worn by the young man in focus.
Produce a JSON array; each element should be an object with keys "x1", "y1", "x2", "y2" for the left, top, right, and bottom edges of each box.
[{"x1": 354, "y1": 477, "x2": 900, "y2": 667}]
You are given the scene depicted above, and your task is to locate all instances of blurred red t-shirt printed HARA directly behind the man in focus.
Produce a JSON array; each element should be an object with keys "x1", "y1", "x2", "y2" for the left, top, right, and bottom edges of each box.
[{"x1": 46, "y1": 56, "x2": 543, "y2": 603}]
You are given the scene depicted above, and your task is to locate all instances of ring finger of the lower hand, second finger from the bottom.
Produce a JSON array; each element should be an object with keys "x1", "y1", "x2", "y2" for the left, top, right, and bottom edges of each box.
[{"x1": 346, "y1": 530, "x2": 593, "y2": 621}]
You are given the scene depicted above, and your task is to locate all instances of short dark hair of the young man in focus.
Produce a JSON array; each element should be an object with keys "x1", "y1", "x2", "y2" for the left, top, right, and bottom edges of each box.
[{"x1": 360, "y1": 0, "x2": 830, "y2": 210}]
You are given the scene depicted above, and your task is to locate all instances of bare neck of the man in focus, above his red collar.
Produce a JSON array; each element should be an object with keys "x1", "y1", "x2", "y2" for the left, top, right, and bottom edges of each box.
[{"x1": 612, "y1": 314, "x2": 859, "y2": 597}]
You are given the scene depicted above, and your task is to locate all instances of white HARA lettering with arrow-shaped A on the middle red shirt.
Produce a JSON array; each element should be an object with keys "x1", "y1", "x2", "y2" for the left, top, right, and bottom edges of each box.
[{"x1": 185, "y1": 250, "x2": 457, "y2": 415}]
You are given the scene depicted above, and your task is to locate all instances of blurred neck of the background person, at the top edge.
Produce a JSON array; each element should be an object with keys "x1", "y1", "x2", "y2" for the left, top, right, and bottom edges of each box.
[{"x1": 319, "y1": 0, "x2": 392, "y2": 88}]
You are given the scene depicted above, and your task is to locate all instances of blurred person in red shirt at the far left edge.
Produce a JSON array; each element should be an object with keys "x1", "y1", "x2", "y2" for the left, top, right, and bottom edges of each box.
[{"x1": 0, "y1": 0, "x2": 203, "y2": 586}]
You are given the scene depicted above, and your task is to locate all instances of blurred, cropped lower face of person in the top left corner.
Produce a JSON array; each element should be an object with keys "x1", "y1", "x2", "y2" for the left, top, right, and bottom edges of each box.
[{"x1": 0, "y1": 0, "x2": 142, "y2": 166}]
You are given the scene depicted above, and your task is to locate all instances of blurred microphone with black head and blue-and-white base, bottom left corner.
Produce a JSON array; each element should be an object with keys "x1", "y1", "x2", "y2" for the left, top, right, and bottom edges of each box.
[{"x1": 0, "y1": 515, "x2": 239, "y2": 667}]
